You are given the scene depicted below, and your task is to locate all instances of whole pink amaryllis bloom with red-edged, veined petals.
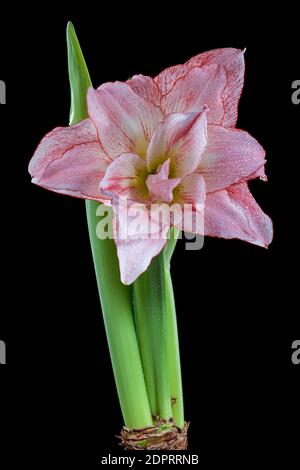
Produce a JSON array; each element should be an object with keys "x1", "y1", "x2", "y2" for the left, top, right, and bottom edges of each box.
[{"x1": 29, "y1": 48, "x2": 273, "y2": 284}]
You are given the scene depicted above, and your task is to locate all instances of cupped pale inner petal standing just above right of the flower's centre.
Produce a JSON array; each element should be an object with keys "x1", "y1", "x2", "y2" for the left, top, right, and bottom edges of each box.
[{"x1": 147, "y1": 111, "x2": 207, "y2": 177}]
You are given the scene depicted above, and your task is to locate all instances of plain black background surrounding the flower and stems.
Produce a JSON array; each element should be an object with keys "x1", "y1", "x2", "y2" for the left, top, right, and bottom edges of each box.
[{"x1": 0, "y1": 4, "x2": 300, "y2": 468}]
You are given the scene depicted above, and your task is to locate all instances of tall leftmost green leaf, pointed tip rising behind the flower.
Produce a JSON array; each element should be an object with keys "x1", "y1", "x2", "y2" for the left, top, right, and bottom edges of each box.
[{"x1": 67, "y1": 23, "x2": 152, "y2": 428}]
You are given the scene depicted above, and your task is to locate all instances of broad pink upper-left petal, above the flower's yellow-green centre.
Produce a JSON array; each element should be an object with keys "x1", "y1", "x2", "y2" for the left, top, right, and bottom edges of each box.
[{"x1": 88, "y1": 82, "x2": 162, "y2": 158}]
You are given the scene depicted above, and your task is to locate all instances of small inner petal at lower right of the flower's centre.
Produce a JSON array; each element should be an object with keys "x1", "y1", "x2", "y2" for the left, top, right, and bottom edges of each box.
[{"x1": 174, "y1": 173, "x2": 206, "y2": 235}]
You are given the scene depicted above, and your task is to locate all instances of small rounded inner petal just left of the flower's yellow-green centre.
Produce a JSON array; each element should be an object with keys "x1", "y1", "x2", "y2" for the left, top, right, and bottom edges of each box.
[{"x1": 99, "y1": 153, "x2": 148, "y2": 201}]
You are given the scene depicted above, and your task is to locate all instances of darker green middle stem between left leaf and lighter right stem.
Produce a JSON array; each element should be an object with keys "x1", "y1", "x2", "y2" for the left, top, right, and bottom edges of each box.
[{"x1": 133, "y1": 252, "x2": 172, "y2": 420}]
